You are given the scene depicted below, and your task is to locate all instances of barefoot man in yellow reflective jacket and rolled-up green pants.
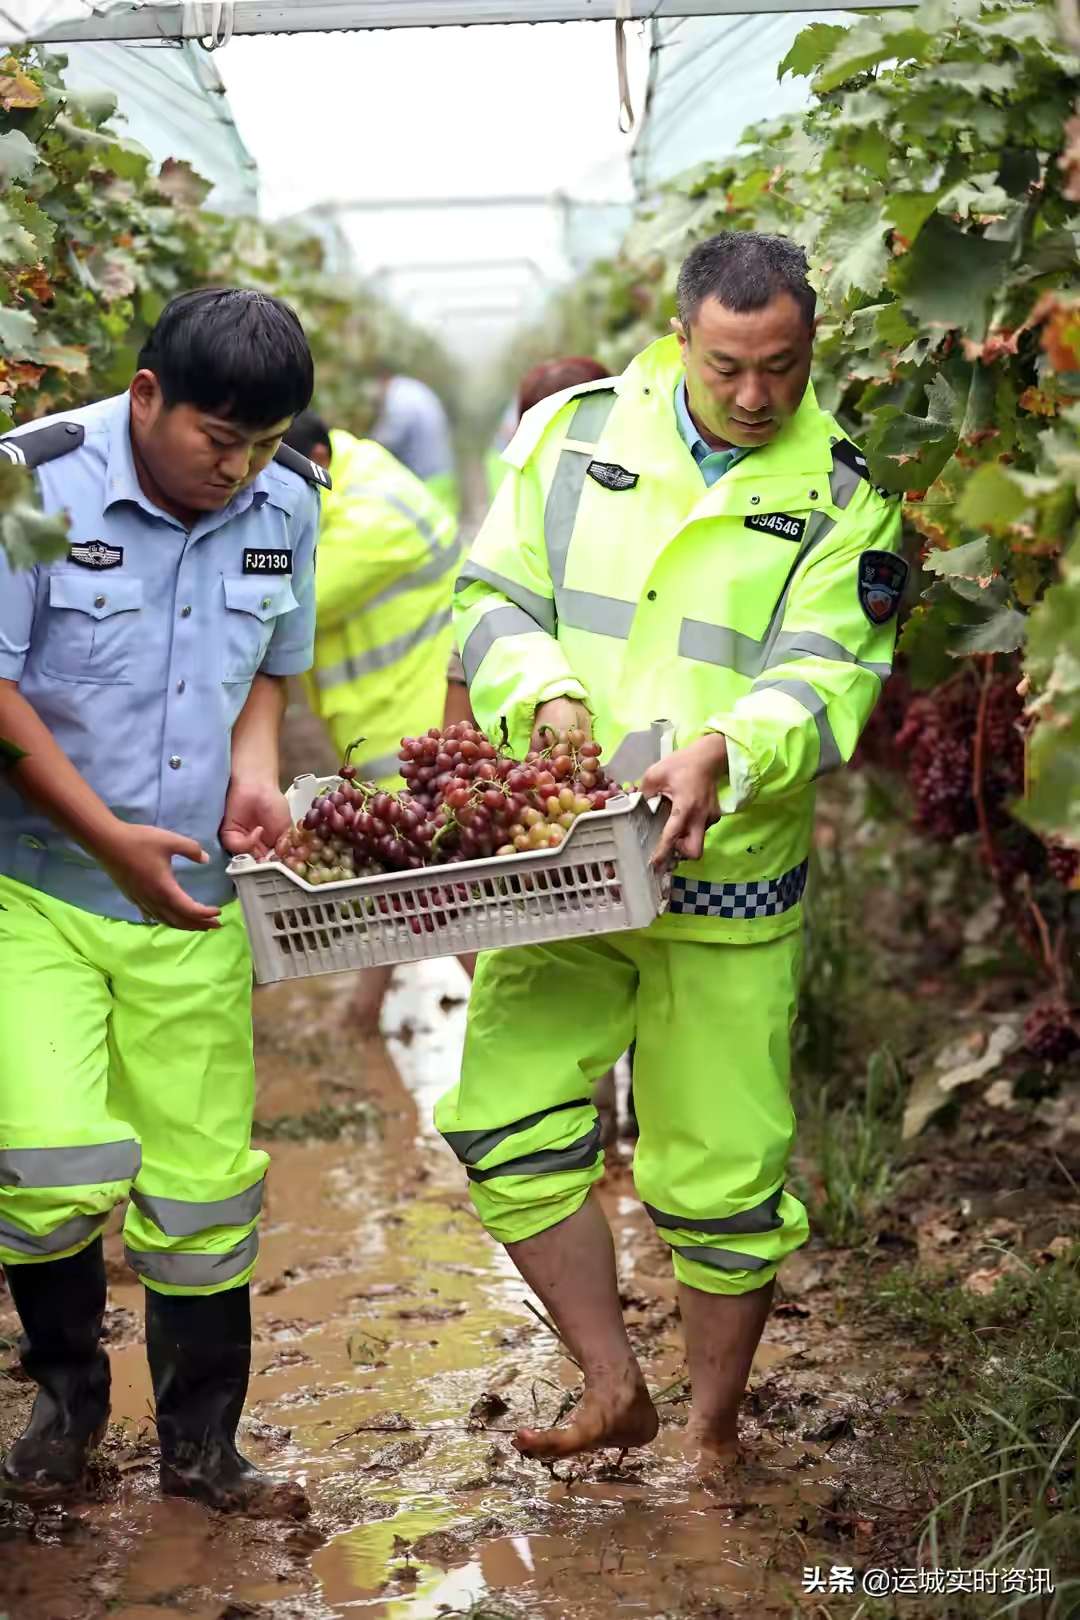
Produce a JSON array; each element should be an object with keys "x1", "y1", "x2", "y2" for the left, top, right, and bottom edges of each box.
[{"x1": 437, "y1": 233, "x2": 907, "y2": 1468}]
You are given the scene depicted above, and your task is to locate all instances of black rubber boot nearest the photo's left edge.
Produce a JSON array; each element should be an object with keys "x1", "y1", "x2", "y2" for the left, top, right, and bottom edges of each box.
[{"x1": 0, "y1": 1238, "x2": 108, "y2": 1503}]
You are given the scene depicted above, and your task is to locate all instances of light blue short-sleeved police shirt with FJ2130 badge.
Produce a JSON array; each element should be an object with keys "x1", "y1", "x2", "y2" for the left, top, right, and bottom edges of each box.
[{"x1": 0, "y1": 394, "x2": 319, "y2": 922}]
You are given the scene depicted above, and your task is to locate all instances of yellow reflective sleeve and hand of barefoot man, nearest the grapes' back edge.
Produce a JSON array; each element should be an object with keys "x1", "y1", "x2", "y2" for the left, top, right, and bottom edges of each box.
[{"x1": 453, "y1": 465, "x2": 589, "y2": 757}]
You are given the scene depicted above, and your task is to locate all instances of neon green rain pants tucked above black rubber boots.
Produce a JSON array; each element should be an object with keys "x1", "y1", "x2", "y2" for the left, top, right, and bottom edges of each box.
[{"x1": 0, "y1": 876, "x2": 269, "y2": 1294}]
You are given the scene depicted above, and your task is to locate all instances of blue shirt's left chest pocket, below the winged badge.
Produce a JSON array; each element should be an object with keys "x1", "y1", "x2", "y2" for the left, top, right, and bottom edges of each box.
[{"x1": 40, "y1": 573, "x2": 142, "y2": 685}]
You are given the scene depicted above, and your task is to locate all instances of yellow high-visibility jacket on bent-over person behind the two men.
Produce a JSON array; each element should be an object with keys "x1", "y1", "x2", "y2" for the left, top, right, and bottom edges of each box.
[{"x1": 308, "y1": 429, "x2": 460, "y2": 787}]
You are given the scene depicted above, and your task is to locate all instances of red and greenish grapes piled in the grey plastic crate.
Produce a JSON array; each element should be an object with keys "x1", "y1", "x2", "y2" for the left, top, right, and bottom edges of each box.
[{"x1": 274, "y1": 723, "x2": 619, "y2": 885}]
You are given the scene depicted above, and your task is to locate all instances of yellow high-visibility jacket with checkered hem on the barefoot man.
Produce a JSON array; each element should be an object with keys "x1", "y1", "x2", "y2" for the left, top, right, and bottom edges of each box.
[{"x1": 455, "y1": 337, "x2": 907, "y2": 943}]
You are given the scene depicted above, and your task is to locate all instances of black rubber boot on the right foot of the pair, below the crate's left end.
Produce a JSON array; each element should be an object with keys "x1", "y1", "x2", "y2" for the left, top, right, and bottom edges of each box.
[{"x1": 146, "y1": 1286, "x2": 311, "y2": 1518}]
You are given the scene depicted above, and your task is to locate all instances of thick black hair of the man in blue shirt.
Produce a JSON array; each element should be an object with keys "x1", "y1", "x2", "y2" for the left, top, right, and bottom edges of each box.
[{"x1": 139, "y1": 287, "x2": 314, "y2": 428}]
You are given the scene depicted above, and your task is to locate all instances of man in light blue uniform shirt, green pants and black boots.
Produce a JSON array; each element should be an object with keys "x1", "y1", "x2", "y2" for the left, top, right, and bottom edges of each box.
[{"x1": 0, "y1": 288, "x2": 327, "y2": 1515}]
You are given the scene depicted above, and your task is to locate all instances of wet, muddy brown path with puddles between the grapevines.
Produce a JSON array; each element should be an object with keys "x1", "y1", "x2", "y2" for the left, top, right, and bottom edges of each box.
[{"x1": 0, "y1": 962, "x2": 984, "y2": 1620}]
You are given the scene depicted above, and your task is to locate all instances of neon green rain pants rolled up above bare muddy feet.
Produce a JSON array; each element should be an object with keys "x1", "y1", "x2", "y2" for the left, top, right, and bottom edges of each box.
[{"x1": 436, "y1": 933, "x2": 806, "y2": 1294}]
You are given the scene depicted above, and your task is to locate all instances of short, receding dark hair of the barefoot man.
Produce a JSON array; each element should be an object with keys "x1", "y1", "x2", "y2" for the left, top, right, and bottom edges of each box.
[{"x1": 677, "y1": 230, "x2": 818, "y2": 334}]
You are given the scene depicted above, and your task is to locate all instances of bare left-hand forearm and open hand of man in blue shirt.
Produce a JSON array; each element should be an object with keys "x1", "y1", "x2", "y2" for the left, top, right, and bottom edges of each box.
[{"x1": 0, "y1": 680, "x2": 219, "y2": 932}]
